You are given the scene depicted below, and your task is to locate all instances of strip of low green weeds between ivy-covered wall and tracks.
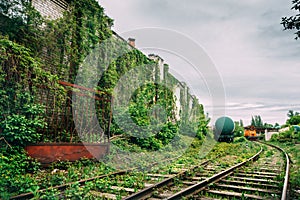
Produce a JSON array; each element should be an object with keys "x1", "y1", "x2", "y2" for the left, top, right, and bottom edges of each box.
[{"x1": 0, "y1": 136, "x2": 259, "y2": 199}]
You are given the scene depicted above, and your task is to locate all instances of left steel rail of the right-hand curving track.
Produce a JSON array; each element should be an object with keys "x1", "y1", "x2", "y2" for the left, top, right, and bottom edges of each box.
[{"x1": 166, "y1": 147, "x2": 263, "y2": 200}]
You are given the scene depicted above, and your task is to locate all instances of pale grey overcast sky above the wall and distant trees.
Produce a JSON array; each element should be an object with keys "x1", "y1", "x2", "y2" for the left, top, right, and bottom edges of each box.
[{"x1": 99, "y1": 0, "x2": 300, "y2": 124}]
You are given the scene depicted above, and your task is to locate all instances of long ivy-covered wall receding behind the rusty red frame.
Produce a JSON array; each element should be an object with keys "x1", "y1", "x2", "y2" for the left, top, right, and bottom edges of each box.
[{"x1": 0, "y1": 0, "x2": 207, "y2": 149}]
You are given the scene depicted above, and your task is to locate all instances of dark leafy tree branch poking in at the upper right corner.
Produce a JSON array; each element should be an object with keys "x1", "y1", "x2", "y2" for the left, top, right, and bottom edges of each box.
[{"x1": 281, "y1": 0, "x2": 300, "y2": 40}]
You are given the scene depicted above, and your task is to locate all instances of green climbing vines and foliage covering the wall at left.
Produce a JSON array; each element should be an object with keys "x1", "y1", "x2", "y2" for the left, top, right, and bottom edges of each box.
[{"x1": 0, "y1": 0, "x2": 207, "y2": 198}]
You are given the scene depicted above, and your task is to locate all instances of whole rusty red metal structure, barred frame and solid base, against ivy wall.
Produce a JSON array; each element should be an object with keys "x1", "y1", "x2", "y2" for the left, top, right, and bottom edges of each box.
[{"x1": 25, "y1": 81, "x2": 113, "y2": 165}]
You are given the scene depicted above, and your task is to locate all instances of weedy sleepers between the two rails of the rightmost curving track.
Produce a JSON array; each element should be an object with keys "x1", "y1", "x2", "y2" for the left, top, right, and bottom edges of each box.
[{"x1": 190, "y1": 142, "x2": 289, "y2": 200}]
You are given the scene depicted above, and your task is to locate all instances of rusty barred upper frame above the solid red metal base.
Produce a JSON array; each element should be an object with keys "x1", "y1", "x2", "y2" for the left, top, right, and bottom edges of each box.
[{"x1": 36, "y1": 81, "x2": 112, "y2": 143}]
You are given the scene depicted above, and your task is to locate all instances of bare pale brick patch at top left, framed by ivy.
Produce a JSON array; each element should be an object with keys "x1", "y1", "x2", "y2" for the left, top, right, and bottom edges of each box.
[{"x1": 32, "y1": 0, "x2": 68, "y2": 20}]
